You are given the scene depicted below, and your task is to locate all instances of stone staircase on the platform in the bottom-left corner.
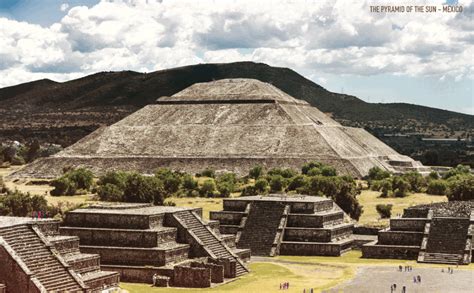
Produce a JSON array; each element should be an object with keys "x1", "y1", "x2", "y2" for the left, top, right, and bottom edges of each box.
[{"x1": 0, "y1": 225, "x2": 84, "y2": 292}]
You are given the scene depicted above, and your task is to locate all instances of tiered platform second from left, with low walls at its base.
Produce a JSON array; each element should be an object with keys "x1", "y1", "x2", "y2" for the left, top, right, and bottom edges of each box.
[{"x1": 60, "y1": 204, "x2": 250, "y2": 288}]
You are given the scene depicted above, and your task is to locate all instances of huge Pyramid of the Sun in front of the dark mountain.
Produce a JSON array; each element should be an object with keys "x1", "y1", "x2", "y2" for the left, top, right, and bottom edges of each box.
[{"x1": 12, "y1": 79, "x2": 428, "y2": 178}]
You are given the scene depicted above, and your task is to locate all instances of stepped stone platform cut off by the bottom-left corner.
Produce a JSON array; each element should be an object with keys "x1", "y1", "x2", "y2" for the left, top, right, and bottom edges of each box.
[{"x1": 0, "y1": 217, "x2": 119, "y2": 293}]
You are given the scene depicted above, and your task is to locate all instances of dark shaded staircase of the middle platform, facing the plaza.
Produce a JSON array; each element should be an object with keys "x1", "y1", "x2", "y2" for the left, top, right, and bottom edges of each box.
[{"x1": 237, "y1": 201, "x2": 286, "y2": 256}]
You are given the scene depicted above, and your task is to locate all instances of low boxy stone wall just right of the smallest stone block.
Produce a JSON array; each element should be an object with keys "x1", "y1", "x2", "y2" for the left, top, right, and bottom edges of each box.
[{"x1": 173, "y1": 266, "x2": 211, "y2": 288}]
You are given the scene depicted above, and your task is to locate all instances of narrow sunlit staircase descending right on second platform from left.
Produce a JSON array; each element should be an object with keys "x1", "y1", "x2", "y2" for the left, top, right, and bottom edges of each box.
[{"x1": 173, "y1": 210, "x2": 248, "y2": 276}]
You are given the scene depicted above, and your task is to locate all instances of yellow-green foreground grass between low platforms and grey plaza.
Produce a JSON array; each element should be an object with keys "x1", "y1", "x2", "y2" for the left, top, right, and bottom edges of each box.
[{"x1": 121, "y1": 251, "x2": 474, "y2": 293}]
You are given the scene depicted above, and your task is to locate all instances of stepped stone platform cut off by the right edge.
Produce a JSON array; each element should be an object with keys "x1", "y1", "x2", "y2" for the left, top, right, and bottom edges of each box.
[{"x1": 362, "y1": 202, "x2": 474, "y2": 264}]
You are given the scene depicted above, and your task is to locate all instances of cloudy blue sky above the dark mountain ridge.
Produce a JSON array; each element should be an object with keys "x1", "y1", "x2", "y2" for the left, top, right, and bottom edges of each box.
[{"x1": 0, "y1": 0, "x2": 474, "y2": 114}]
